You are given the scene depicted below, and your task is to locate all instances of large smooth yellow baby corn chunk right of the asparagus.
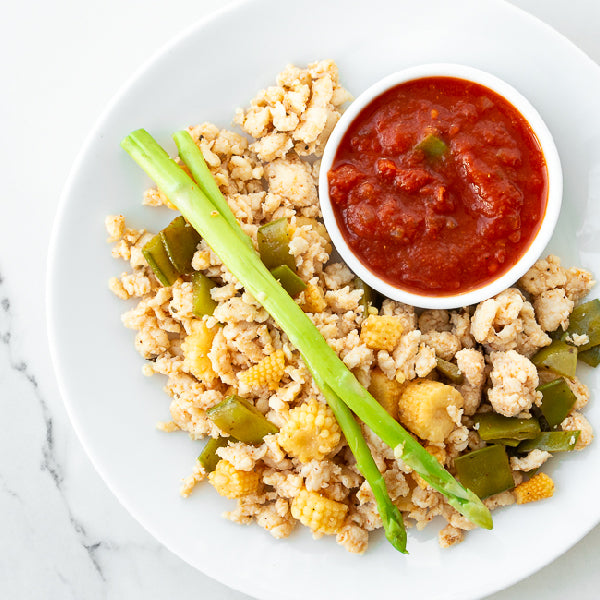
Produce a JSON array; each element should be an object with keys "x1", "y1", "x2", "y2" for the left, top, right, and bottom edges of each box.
[{"x1": 398, "y1": 379, "x2": 464, "y2": 444}]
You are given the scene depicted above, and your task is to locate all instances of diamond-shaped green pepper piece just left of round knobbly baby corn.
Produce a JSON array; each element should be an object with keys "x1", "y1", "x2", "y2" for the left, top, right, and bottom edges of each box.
[{"x1": 206, "y1": 396, "x2": 279, "y2": 444}]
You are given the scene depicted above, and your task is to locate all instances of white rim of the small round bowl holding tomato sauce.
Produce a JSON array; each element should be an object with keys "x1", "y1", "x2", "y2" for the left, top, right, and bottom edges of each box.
[{"x1": 319, "y1": 63, "x2": 563, "y2": 308}]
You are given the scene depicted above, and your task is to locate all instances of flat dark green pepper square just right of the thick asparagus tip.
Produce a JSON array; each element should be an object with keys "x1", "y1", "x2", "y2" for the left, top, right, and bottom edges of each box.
[{"x1": 454, "y1": 444, "x2": 515, "y2": 498}]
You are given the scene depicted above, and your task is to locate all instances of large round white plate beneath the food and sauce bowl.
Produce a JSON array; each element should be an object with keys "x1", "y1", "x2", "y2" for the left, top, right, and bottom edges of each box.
[{"x1": 48, "y1": 0, "x2": 600, "y2": 600}]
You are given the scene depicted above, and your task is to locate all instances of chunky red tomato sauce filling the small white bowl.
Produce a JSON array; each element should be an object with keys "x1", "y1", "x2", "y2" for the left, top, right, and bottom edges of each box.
[{"x1": 327, "y1": 77, "x2": 548, "y2": 296}]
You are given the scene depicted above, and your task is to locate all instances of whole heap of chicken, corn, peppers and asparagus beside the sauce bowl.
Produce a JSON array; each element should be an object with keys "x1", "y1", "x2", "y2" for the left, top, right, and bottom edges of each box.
[{"x1": 107, "y1": 61, "x2": 596, "y2": 553}]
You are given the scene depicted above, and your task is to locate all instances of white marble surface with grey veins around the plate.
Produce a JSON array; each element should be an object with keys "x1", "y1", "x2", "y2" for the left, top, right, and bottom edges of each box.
[{"x1": 0, "y1": 0, "x2": 600, "y2": 600}]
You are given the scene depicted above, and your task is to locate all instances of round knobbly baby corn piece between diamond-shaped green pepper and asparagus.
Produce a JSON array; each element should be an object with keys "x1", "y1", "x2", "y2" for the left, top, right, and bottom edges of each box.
[{"x1": 278, "y1": 398, "x2": 341, "y2": 463}]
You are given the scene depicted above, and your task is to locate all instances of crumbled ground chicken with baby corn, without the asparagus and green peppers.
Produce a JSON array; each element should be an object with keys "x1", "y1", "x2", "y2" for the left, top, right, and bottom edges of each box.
[{"x1": 106, "y1": 61, "x2": 594, "y2": 553}]
